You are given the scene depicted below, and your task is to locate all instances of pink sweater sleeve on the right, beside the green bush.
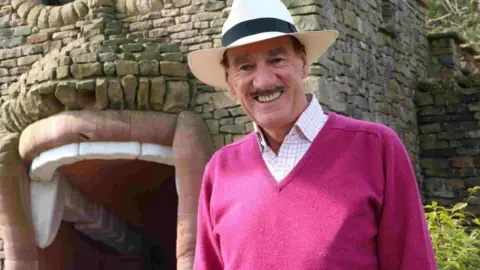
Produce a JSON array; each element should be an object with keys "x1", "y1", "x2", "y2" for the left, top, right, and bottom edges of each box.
[{"x1": 378, "y1": 130, "x2": 437, "y2": 270}]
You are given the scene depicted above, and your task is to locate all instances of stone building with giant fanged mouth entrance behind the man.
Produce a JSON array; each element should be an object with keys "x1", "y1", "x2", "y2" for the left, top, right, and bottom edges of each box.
[{"x1": 0, "y1": 0, "x2": 475, "y2": 269}]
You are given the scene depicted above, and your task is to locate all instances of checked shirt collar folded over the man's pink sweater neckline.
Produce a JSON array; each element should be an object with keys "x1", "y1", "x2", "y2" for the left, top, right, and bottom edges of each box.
[{"x1": 253, "y1": 93, "x2": 328, "y2": 152}]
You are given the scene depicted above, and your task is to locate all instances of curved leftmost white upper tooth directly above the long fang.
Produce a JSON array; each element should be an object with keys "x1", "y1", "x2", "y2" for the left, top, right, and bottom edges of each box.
[{"x1": 30, "y1": 143, "x2": 82, "y2": 181}]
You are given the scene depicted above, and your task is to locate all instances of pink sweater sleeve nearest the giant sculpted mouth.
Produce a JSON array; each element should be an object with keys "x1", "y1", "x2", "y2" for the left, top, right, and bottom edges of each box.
[{"x1": 193, "y1": 161, "x2": 223, "y2": 270}]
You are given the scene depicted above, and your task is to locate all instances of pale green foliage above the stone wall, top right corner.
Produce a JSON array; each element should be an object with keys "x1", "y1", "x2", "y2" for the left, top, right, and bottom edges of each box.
[{"x1": 427, "y1": 0, "x2": 480, "y2": 49}]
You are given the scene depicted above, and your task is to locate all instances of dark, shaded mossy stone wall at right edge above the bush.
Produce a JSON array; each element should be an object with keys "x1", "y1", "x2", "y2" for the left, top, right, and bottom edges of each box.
[{"x1": 416, "y1": 33, "x2": 480, "y2": 209}]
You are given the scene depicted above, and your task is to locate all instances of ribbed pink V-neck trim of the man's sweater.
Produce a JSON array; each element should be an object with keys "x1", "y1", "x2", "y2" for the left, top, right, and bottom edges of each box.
[{"x1": 252, "y1": 112, "x2": 337, "y2": 192}]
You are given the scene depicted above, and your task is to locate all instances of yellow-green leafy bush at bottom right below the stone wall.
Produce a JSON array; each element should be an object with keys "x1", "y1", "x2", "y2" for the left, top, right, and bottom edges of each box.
[{"x1": 425, "y1": 186, "x2": 480, "y2": 270}]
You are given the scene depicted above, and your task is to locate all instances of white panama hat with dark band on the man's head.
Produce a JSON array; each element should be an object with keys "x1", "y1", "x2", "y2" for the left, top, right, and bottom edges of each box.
[{"x1": 188, "y1": 0, "x2": 338, "y2": 89}]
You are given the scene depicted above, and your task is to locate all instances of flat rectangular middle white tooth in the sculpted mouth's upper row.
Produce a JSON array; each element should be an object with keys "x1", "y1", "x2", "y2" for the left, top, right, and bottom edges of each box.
[{"x1": 79, "y1": 142, "x2": 141, "y2": 160}]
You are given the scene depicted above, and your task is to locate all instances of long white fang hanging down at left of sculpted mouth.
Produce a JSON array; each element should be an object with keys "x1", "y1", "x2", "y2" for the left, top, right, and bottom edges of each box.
[{"x1": 30, "y1": 173, "x2": 66, "y2": 248}]
